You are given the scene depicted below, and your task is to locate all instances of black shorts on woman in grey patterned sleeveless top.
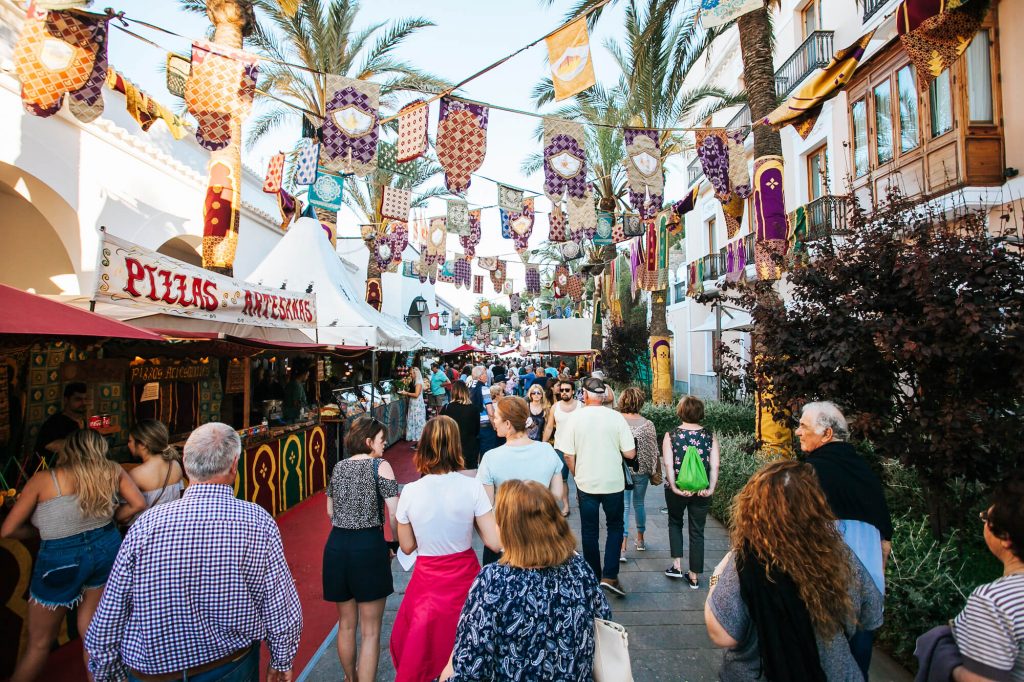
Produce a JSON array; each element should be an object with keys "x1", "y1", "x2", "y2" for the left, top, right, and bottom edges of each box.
[{"x1": 324, "y1": 527, "x2": 394, "y2": 602}]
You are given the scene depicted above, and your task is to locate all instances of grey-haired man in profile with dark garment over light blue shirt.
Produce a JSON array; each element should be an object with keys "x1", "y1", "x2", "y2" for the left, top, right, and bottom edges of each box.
[{"x1": 797, "y1": 401, "x2": 893, "y2": 680}]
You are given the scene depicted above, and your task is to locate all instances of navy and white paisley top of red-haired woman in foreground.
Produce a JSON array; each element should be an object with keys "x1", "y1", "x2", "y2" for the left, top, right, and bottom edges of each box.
[{"x1": 450, "y1": 555, "x2": 611, "y2": 682}]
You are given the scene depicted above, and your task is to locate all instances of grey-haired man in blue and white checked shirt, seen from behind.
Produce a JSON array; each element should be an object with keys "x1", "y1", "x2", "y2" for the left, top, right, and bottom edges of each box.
[{"x1": 85, "y1": 423, "x2": 302, "y2": 682}]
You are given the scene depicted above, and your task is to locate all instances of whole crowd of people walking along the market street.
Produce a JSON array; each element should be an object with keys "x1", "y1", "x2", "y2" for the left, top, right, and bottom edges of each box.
[{"x1": 0, "y1": 366, "x2": 1024, "y2": 682}]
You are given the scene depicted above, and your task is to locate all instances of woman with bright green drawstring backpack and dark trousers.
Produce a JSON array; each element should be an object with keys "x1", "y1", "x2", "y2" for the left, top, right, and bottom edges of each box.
[{"x1": 662, "y1": 395, "x2": 719, "y2": 590}]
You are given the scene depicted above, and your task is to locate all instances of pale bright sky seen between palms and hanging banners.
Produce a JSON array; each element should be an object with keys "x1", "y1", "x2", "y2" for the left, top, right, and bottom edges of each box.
[{"x1": 108, "y1": 0, "x2": 685, "y2": 311}]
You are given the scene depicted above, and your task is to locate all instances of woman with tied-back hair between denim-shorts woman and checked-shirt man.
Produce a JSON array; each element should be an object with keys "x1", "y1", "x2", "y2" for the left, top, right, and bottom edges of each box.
[{"x1": 128, "y1": 419, "x2": 184, "y2": 508}]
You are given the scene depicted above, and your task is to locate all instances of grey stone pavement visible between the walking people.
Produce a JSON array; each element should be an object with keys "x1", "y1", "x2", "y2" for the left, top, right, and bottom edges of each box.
[{"x1": 298, "y1": 477, "x2": 912, "y2": 682}]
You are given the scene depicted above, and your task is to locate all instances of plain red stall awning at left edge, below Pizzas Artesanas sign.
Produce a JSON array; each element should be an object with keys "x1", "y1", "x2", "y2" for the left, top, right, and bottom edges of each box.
[{"x1": 0, "y1": 284, "x2": 164, "y2": 341}]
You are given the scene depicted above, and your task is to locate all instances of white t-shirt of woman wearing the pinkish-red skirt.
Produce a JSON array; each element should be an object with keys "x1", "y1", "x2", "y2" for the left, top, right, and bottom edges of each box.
[{"x1": 395, "y1": 471, "x2": 490, "y2": 556}]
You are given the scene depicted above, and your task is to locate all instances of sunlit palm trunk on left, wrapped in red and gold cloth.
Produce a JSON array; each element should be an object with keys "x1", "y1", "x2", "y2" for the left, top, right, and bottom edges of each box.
[{"x1": 203, "y1": 0, "x2": 252, "y2": 276}]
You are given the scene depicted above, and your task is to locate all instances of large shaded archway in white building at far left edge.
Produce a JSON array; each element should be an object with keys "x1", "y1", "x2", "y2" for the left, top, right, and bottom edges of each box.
[{"x1": 0, "y1": 180, "x2": 81, "y2": 294}]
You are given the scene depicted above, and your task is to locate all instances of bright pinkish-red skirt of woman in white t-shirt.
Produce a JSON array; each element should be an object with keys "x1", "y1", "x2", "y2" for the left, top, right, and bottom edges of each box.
[{"x1": 390, "y1": 549, "x2": 480, "y2": 682}]
